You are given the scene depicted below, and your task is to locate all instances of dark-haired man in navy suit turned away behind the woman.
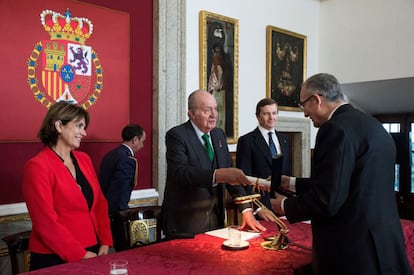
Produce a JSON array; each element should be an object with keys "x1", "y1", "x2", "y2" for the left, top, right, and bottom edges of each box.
[{"x1": 99, "y1": 124, "x2": 146, "y2": 216}]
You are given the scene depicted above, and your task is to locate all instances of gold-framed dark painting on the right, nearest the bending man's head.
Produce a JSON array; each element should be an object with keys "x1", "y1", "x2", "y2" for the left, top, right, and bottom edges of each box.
[{"x1": 266, "y1": 26, "x2": 306, "y2": 111}]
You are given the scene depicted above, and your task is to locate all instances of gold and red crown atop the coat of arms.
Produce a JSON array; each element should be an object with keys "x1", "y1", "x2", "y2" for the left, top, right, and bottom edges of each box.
[{"x1": 40, "y1": 9, "x2": 93, "y2": 44}]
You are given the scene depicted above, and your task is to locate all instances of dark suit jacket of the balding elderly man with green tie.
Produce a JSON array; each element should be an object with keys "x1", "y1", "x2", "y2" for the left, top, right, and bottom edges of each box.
[{"x1": 162, "y1": 121, "x2": 245, "y2": 236}]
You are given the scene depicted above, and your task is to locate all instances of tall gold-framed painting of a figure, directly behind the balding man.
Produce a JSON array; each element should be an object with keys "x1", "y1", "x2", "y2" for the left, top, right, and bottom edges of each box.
[{"x1": 200, "y1": 11, "x2": 239, "y2": 143}]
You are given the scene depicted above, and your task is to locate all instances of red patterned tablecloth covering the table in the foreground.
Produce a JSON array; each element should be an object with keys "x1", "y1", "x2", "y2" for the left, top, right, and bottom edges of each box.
[{"x1": 21, "y1": 223, "x2": 312, "y2": 275}]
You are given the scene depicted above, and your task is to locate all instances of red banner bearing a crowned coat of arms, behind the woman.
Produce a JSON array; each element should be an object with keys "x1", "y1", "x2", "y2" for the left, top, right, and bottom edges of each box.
[{"x1": 0, "y1": 0, "x2": 129, "y2": 141}]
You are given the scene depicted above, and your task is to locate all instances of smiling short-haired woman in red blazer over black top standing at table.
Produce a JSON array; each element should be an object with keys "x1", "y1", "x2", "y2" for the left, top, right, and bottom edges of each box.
[{"x1": 23, "y1": 102, "x2": 112, "y2": 270}]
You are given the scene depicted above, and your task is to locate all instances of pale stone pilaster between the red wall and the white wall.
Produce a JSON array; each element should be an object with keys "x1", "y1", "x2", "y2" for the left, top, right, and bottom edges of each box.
[{"x1": 152, "y1": 0, "x2": 187, "y2": 203}]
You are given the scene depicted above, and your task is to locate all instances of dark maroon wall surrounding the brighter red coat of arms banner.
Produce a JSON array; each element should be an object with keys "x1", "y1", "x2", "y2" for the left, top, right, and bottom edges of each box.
[{"x1": 0, "y1": 0, "x2": 153, "y2": 204}]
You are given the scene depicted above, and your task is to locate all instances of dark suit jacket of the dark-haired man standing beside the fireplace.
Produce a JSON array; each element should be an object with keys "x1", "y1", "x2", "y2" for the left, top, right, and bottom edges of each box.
[{"x1": 236, "y1": 127, "x2": 292, "y2": 209}]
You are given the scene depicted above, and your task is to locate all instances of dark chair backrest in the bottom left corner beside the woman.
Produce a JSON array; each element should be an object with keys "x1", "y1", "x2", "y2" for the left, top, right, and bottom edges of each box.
[{"x1": 2, "y1": 230, "x2": 31, "y2": 275}]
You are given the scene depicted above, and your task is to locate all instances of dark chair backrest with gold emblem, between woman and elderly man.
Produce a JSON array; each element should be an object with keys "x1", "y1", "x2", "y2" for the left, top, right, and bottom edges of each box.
[{"x1": 112, "y1": 206, "x2": 162, "y2": 251}]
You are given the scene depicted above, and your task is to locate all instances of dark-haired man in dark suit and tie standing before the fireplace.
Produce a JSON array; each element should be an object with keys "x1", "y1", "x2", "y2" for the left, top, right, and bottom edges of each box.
[{"x1": 236, "y1": 98, "x2": 292, "y2": 219}]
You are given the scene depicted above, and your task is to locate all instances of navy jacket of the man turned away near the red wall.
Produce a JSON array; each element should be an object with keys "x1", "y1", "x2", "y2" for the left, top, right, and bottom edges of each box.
[{"x1": 99, "y1": 145, "x2": 136, "y2": 217}]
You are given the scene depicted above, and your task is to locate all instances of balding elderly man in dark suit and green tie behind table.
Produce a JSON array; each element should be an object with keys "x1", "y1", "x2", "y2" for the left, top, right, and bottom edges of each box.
[{"x1": 162, "y1": 90, "x2": 266, "y2": 238}]
